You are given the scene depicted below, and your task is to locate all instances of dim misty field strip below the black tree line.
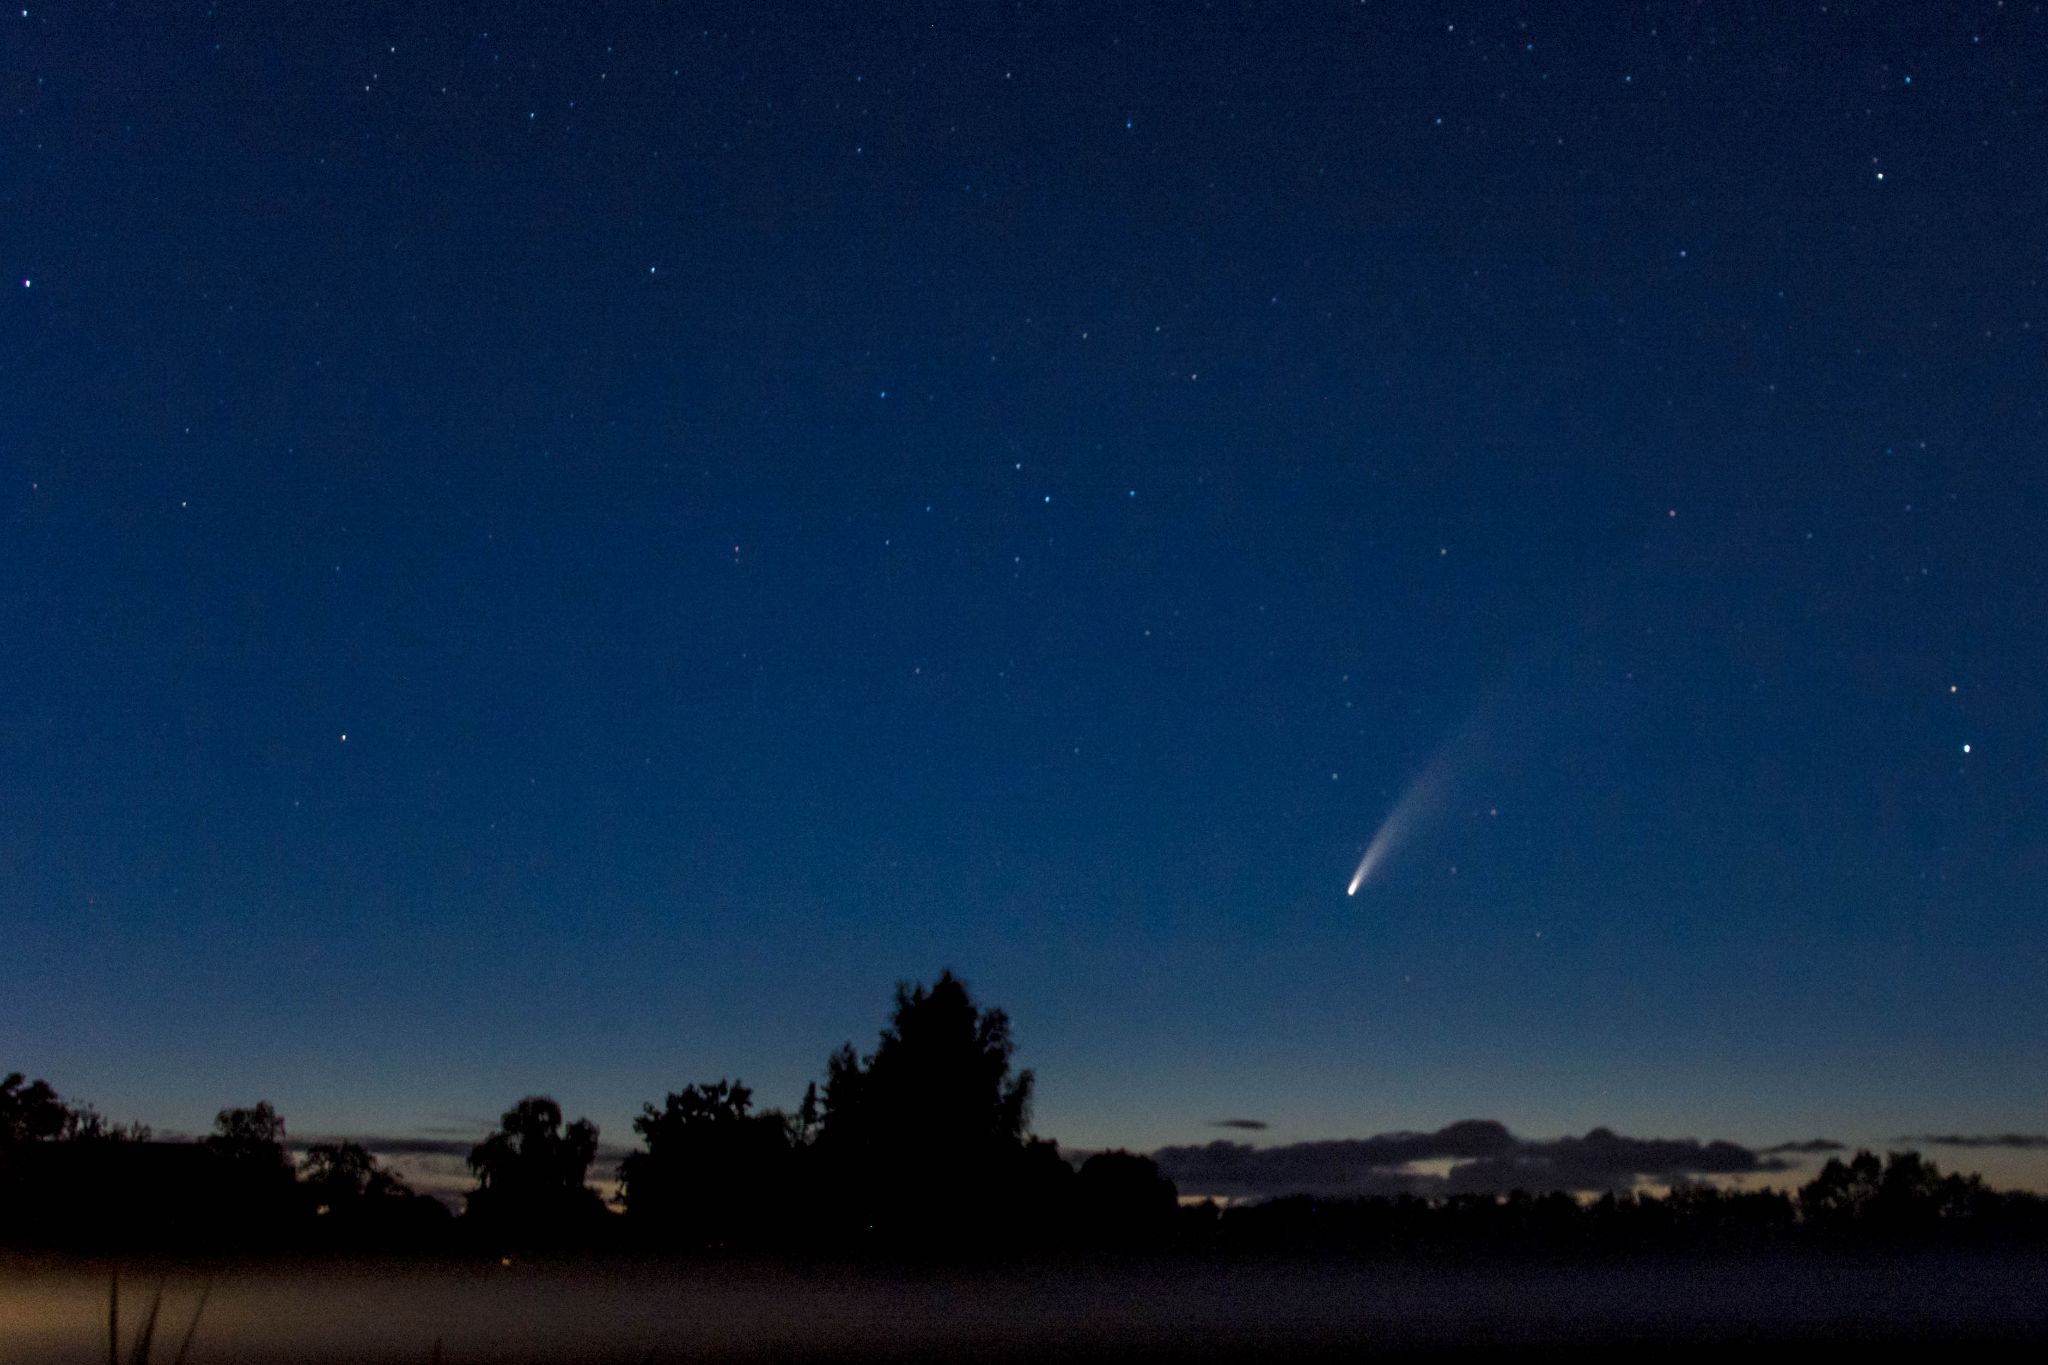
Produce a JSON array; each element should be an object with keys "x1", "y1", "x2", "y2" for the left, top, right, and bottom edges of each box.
[{"x1": 0, "y1": 1252, "x2": 2048, "y2": 1365}]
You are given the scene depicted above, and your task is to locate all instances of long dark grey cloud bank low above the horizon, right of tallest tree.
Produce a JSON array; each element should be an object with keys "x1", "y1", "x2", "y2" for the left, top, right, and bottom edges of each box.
[{"x1": 1153, "y1": 1119, "x2": 1788, "y2": 1199}]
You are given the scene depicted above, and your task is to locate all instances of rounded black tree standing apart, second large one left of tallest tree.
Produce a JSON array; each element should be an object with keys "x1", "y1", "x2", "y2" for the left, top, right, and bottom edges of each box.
[{"x1": 469, "y1": 1095, "x2": 604, "y2": 1240}]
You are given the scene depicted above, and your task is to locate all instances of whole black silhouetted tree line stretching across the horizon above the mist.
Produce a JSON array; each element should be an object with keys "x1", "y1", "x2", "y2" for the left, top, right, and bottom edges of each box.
[{"x1": 0, "y1": 972, "x2": 2048, "y2": 1254}]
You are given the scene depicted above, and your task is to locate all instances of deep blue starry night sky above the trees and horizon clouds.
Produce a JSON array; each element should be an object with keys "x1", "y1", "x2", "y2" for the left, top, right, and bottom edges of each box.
[{"x1": 0, "y1": 0, "x2": 2048, "y2": 1183}]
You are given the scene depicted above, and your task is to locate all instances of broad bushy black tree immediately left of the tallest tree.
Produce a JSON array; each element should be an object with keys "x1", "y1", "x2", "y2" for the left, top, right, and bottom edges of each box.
[{"x1": 618, "y1": 1081, "x2": 805, "y2": 1246}]
